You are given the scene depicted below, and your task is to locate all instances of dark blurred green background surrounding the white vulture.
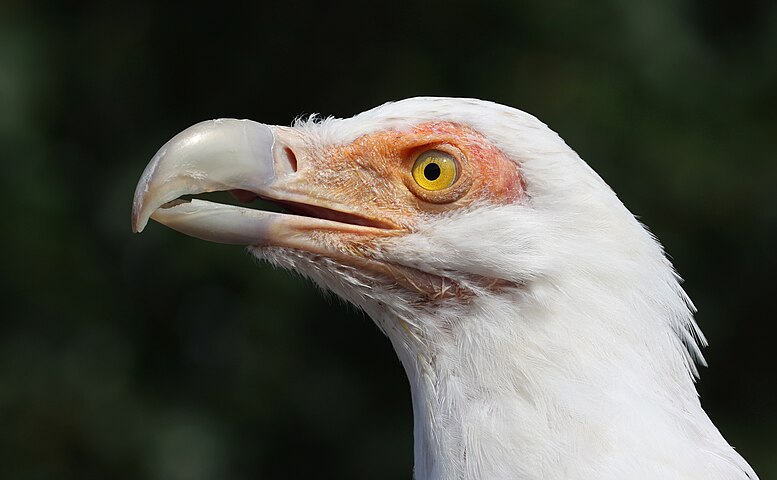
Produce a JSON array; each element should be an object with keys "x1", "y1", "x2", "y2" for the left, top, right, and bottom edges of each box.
[{"x1": 0, "y1": 0, "x2": 777, "y2": 480}]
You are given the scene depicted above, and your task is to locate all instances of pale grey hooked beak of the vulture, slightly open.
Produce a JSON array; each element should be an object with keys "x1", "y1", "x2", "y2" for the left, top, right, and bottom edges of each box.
[{"x1": 132, "y1": 119, "x2": 398, "y2": 254}]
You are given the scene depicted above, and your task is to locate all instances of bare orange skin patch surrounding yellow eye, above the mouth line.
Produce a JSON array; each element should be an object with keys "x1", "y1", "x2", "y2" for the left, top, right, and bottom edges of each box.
[{"x1": 287, "y1": 122, "x2": 525, "y2": 231}]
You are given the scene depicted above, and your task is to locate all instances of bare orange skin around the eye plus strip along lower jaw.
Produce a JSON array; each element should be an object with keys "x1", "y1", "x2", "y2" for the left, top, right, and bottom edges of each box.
[{"x1": 242, "y1": 122, "x2": 525, "y2": 301}]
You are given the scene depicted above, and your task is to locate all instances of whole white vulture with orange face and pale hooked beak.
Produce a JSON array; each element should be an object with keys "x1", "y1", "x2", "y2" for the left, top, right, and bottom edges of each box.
[{"x1": 132, "y1": 98, "x2": 757, "y2": 480}]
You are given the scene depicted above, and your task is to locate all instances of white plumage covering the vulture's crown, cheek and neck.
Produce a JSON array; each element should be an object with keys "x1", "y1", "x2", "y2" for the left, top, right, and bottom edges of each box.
[{"x1": 130, "y1": 98, "x2": 757, "y2": 480}]
